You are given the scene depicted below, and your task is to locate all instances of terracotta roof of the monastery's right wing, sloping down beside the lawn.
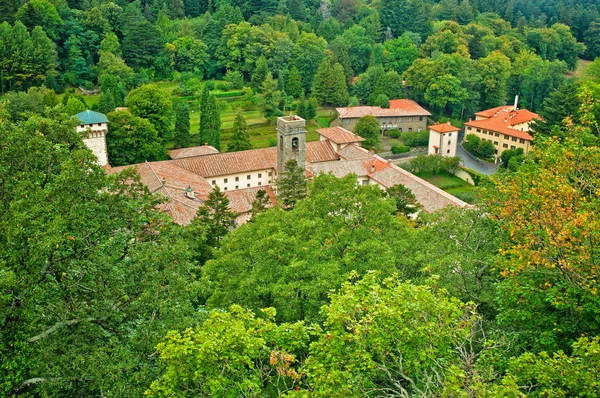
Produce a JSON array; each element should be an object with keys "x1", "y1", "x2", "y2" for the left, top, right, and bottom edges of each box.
[{"x1": 369, "y1": 163, "x2": 469, "y2": 213}]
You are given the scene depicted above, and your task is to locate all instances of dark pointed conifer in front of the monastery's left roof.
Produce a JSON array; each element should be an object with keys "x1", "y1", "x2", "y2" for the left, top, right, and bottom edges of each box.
[{"x1": 195, "y1": 186, "x2": 235, "y2": 247}]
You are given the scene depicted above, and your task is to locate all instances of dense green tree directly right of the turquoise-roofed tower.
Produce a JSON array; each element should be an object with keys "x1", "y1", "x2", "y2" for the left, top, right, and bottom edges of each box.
[{"x1": 106, "y1": 111, "x2": 168, "y2": 166}]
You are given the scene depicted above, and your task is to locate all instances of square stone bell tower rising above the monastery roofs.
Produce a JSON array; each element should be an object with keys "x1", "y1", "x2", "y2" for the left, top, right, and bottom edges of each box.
[{"x1": 277, "y1": 115, "x2": 306, "y2": 175}]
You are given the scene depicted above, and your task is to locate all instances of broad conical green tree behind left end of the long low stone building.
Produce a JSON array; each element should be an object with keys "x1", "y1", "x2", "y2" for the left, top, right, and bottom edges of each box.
[{"x1": 312, "y1": 52, "x2": 348, "y2": 106}]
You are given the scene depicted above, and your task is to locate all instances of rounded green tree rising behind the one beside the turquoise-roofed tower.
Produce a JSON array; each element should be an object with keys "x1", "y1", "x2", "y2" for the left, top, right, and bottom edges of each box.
[{"x1": 125, "y1": 84, "x2": 173, "y2": 142}]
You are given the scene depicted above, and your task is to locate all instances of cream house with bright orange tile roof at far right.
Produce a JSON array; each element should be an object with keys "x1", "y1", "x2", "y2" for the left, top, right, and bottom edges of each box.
[{"x1": 465, "y1": 106, "x2": 541, "y2": 158}]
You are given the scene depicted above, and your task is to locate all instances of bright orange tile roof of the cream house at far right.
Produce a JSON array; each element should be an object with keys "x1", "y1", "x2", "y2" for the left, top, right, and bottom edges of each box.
[{"x1": 465, "y1": 106, "x2": 541, "y2": 141}]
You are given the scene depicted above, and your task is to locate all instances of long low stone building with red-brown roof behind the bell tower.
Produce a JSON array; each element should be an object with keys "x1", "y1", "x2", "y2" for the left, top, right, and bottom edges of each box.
[{"x1": 331, "y1": 99, "x2": 431, "y2": 132}]
